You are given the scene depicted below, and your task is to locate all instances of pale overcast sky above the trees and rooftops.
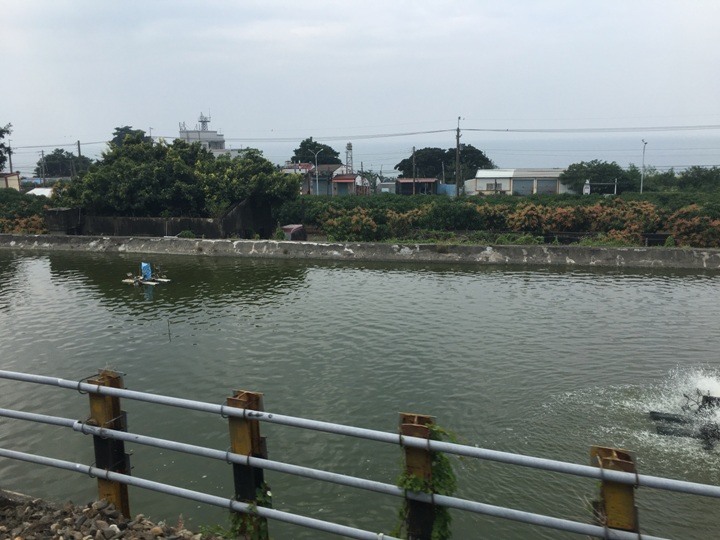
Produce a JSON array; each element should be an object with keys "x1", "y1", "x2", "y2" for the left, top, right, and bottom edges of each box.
[{"x1": 0, "y1": 0, "x2": 720, "y2": 175}]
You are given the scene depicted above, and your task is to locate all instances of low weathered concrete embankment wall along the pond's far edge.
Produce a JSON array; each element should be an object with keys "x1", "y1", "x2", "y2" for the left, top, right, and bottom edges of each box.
[{"x1": 0, "y1": 234, "x2": 720, "y2": 270}]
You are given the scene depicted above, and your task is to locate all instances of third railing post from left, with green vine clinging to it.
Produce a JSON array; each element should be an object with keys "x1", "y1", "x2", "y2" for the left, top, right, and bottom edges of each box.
[{"x1": 400, "y1": 413, "x2": 435, "y2": 540}]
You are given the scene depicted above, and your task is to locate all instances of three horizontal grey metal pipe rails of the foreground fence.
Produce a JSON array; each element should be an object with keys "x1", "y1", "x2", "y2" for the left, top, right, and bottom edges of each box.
[{"x1": 0, "y1": 370, "x2": 720, "y2": 540}]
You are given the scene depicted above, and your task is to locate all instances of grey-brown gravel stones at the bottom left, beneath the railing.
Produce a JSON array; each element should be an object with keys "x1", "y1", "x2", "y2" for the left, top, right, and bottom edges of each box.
[{"x1": 0, "y1": 490, "x2": 217, "y2": 540}]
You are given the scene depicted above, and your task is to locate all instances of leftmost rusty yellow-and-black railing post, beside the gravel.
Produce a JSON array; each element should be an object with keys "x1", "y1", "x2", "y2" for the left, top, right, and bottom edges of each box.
[{"x1": 87, "y1": 370, "x2": 131, "y2": 518}]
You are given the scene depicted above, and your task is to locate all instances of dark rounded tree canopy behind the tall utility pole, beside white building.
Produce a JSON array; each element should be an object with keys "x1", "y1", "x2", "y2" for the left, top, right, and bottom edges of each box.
[{"x1": 395, "y1": 144, "x2": 495, "y2": 182}]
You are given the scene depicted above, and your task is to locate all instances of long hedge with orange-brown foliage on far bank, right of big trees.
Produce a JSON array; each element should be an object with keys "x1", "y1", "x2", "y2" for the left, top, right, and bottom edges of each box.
[{"x1": 278, "y1": 194, "x2": 720, "y2": 247}]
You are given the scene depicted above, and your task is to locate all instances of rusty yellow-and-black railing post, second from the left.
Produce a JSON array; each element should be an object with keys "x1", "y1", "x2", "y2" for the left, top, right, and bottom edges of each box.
[{"x1": 227, "y1": 390, "x2": 270, "y2": 539}]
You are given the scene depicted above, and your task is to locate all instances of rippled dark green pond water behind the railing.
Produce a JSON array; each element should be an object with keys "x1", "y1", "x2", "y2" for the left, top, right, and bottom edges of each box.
[{"x1": 0, "y1": 252, "x2": 720, "y2": 539}]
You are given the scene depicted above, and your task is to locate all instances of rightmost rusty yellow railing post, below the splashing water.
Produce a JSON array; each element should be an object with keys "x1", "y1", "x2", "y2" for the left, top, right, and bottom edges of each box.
[{"x1": 590, "y1": 446, "x2": 640, "y2": 532}]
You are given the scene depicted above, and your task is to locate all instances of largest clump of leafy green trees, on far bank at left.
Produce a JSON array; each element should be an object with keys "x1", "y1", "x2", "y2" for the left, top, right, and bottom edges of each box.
[{"x1": 56, "y1": 133, "x2": 300, "y2": 217}]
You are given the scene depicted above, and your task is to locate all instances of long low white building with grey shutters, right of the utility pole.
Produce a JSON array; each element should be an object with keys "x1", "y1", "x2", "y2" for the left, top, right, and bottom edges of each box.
[{"x1": 465, "y1": 169, "x2": 573, "y2": 195}]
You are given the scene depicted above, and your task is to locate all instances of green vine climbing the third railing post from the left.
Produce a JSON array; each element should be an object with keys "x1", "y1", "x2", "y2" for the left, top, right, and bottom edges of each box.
[{"x1": 391, "y1": 424, "x2": 457, "y2": 540}]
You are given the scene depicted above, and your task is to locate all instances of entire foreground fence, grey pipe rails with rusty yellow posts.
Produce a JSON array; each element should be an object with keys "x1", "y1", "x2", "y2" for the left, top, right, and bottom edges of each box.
[{"x1": 0, "y1": 370, "x2": 720, "y2": 540}]
